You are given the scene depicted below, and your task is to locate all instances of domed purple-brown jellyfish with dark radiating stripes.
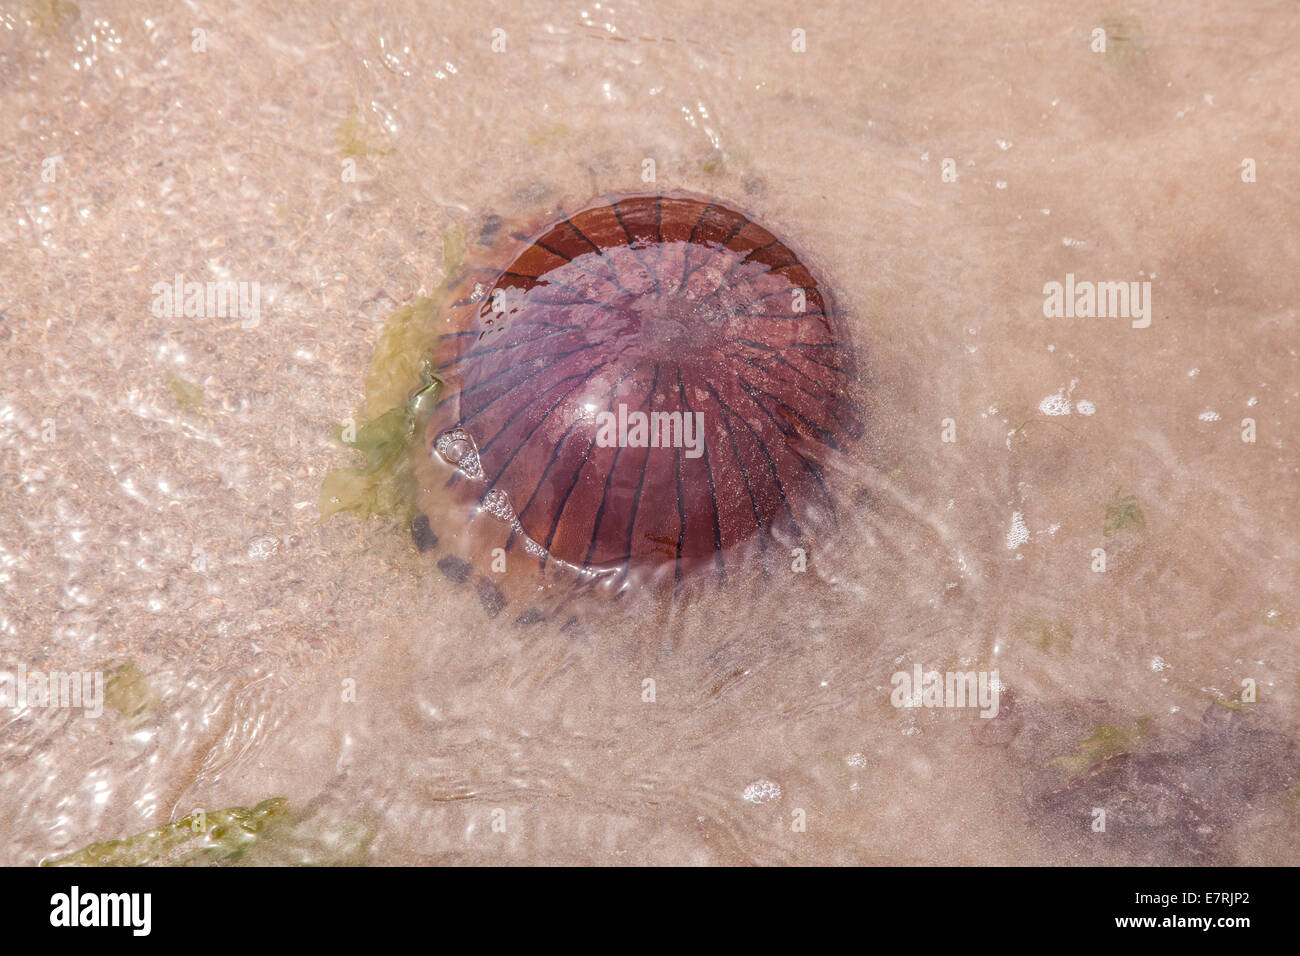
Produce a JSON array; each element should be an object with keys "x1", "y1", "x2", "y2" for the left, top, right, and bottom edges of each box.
[{"x1": 426, "y1": 195, "x2": 861, "y2": 590}]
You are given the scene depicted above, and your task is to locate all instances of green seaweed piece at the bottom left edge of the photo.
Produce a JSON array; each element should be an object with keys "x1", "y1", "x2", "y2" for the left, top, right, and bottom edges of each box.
[{"x1": 42, "y1": 797, "x2": 287, "y2": 866}]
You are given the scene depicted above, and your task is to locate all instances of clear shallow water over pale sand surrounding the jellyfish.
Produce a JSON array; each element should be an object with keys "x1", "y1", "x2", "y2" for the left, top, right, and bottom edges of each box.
[{"x1": 0, "y1": 3, "x2": 1300, "y2": 864}]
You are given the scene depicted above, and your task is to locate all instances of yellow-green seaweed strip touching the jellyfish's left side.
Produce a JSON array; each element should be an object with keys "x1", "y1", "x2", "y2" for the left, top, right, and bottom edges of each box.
[{"x1": 319, "y1": 226, "x2": 465, "y2": 522}]
